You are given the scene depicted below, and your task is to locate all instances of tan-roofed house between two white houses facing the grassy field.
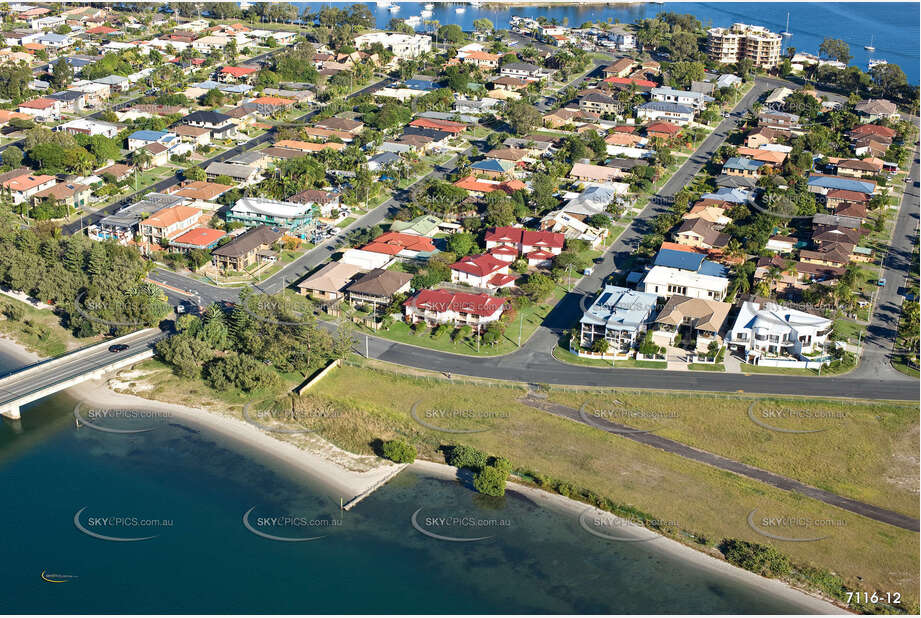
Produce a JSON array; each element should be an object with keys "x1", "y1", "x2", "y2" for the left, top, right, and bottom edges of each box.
[{"x1": 652, "y1": 294, "x2": 732, "y2": 352}]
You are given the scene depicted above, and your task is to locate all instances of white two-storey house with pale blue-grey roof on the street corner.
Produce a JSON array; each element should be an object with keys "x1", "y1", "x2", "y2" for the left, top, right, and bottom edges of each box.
[{"x1": 579, "y1": 285, "x2": 658, "y2": 353}]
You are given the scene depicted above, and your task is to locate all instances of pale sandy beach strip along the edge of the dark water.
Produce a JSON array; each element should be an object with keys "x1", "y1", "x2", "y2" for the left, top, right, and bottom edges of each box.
[{"x1": 0, "y1": 337, "x2": 849, "y2": 614}]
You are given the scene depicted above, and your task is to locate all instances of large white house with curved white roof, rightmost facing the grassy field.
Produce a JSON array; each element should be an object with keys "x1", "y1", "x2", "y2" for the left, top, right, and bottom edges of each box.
[{"x1": 727, "y1": 301, "x2": 832, "y2": 362}]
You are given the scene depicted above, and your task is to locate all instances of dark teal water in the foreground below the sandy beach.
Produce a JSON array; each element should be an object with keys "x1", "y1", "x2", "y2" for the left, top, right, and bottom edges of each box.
[{"x1": 0, "y1": 352, "x2": 820, "y2": 613}]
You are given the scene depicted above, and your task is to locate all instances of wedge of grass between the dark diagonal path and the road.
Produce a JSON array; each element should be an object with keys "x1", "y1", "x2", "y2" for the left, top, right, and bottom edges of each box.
[{"x1": 550, "y1": 390, "x2": 919, "y2": 517}]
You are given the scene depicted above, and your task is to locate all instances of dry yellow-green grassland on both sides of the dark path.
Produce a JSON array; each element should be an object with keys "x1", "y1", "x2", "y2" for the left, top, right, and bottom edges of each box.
[{"x1": 308, "y1": 364, "x2": 918, "y2": 603}]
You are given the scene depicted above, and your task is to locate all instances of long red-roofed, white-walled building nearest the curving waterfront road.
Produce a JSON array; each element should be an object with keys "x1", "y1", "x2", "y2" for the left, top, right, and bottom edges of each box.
[{"x1": 403, "y1": 290, "x2": 506, "y2": 332}]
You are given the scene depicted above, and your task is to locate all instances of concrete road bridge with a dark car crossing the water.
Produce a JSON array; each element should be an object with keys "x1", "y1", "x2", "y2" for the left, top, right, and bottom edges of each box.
[{"x1": 0, "y1": 328, "x2": 166, "y2": 419}]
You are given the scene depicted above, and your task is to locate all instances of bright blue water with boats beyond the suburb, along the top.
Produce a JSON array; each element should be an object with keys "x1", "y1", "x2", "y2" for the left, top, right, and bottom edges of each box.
[{"x1": 295, "y1": 2, "x2": 921, "y2": 84}]
